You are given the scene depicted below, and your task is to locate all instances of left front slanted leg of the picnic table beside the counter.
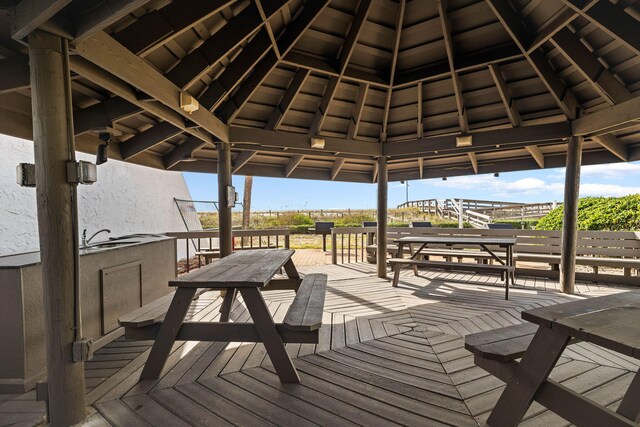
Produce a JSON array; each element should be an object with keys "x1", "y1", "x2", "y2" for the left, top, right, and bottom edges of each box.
[{"x1": 140, "y1": 288, "x2": 198, "y2": 380}]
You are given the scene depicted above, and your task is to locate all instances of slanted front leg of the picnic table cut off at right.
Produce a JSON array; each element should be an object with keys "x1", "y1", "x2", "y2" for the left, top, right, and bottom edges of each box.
[{"x1": 487, "y1": 327, "x2": 571, "y2": 426}]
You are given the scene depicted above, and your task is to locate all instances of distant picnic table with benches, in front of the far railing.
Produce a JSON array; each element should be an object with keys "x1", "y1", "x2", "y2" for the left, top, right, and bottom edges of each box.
[{"x1": 389, "y1": 236, "x2": 516, "y2": 299}]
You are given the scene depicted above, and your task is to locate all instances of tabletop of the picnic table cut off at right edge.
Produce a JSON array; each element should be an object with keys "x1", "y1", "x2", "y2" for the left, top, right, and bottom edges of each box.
[{"x1": 522, "y1": 291, "x2": 640, "y2": 359}]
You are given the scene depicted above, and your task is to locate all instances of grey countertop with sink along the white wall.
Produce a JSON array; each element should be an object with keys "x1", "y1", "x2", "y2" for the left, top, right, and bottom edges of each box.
[{"x1": 0, "y1": 234, "x2": 174, "y2": 269}]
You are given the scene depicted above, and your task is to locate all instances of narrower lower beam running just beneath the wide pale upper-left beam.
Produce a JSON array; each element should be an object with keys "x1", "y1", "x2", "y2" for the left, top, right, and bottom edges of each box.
[{"x1": 69, "y1": 55, "x2": 216, "y2": 147}]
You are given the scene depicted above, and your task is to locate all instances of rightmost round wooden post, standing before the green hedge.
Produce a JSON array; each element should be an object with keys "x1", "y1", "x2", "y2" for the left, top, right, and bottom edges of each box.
[{"x1": 560, "y1": 136, "x2": 582, "y2": 294}]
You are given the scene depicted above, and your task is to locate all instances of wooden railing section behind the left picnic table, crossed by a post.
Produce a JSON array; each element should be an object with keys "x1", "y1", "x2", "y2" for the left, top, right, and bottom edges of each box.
[{"x1": 165, "y1": 228, "x2": 290, "y2": 272}]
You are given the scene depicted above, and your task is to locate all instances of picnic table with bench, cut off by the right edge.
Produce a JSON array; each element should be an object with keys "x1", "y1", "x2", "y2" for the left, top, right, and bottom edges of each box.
[{"x1": 465, "y1": 291, "x2": 640, "y2": 426}]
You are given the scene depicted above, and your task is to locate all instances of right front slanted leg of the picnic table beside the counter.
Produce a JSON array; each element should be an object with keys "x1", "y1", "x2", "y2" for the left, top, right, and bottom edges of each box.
[{"x1": 240, "y1": 288, "x2": 300, "y2": 383}]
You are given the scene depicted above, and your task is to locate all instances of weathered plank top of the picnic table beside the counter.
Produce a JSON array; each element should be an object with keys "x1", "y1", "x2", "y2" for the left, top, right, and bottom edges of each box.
[{"x1": 169, "y1": 249, "x2": 295, "y2": 289}]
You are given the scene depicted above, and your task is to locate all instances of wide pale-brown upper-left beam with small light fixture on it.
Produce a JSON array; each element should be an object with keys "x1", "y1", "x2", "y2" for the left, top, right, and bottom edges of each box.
[{"x1": 76, "y1": 32, "x2": 229, "y2": 142}]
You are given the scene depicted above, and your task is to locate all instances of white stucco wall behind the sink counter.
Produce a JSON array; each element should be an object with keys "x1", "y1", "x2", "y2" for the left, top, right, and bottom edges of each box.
[{"x1": 0, "y1": 135, "x2": 191, "y2": 256}]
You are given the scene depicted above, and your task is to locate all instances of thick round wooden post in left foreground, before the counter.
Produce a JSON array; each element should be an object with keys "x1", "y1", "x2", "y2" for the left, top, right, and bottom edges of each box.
[{"x1": 29, "y1": 31, "x2": 86, "y2": 426}]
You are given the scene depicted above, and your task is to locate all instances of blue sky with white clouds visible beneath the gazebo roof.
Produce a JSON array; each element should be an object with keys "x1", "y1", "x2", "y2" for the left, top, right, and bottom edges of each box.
[{"x1": 184, "y1": 162, "x2": 640, "y2": 210}]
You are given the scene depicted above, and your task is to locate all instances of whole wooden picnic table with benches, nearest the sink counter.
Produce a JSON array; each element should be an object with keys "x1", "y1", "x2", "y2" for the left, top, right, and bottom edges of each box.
[{"x1": 131, "y1": 249, "x2": 327, "y2": 383}]
